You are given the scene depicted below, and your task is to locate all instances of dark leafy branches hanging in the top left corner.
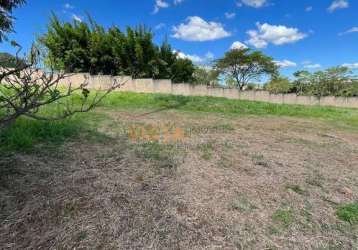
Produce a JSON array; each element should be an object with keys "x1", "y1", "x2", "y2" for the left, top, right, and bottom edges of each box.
[{"x1": 0, "y1": 0, "x2": 26, "y2": 42}]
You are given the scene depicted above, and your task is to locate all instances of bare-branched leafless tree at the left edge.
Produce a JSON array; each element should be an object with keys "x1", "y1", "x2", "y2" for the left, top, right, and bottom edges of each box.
[{"x1": 0, "y1": 43, "x2": 125, "y2": 129}]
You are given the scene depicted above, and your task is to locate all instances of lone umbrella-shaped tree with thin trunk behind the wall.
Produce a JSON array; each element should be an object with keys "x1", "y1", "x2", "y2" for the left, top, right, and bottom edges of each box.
[{"x1": 215, "y1": 49, "x2": 278, "y2": 90}]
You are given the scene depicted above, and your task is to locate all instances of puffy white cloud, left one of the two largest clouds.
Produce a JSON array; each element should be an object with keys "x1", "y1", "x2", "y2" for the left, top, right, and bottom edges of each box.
[{"x1": 173, "y1": 16, "x2": 231, "y2": 42}]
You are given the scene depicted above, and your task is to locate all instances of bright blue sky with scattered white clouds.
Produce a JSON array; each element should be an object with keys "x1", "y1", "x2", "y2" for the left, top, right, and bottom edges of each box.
[{"x1": 0, "y1": 0, "x2": 358, "y2": 75}]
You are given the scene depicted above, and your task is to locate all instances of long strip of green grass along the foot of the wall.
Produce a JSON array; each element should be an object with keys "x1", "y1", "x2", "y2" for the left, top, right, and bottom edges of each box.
[{"x1": 96, "y1": 92, "x2": 358, "y2": 129}]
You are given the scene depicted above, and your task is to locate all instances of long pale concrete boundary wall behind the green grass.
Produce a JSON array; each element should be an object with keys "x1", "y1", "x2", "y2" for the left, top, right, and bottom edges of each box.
[{"x1": 61, "y1": 74, "x2": 358, "y2": 108}]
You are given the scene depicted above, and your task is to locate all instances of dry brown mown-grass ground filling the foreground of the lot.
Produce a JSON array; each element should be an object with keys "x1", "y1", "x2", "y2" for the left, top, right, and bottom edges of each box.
[{"x1": 0, "y1": 110, "x2": 358, "y2": 249}]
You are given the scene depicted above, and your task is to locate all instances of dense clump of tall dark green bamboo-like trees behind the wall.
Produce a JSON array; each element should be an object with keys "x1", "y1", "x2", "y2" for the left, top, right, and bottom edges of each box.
[{"x1": 39, "y1": 15, "x2": 194, "y2": 82}]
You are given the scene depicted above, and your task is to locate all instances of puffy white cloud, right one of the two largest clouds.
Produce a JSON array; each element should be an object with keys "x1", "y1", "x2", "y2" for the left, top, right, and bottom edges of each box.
[{"x1": 246, "y1": 23, "x2": 307, "y2": 49}]
